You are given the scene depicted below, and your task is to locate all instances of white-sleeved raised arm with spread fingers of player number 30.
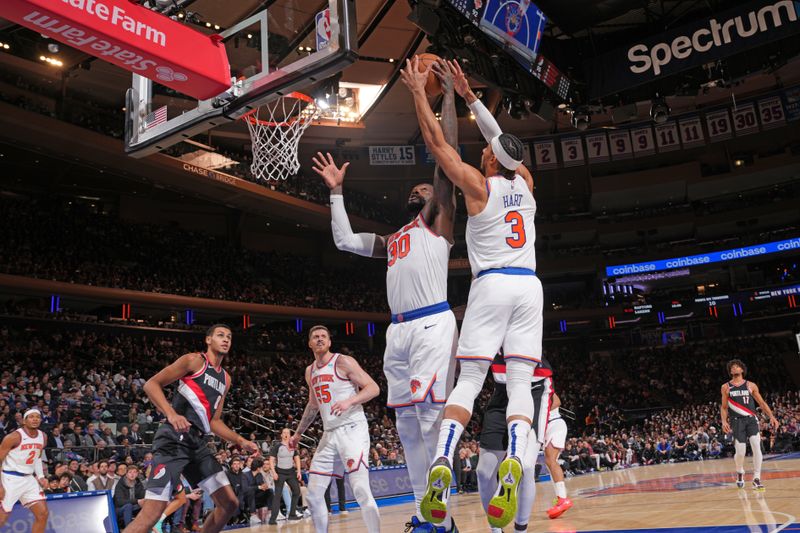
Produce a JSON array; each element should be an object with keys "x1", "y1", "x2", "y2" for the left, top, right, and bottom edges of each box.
[{"x1": 311, "y1": 152, "x2": 386, "y2": 257}]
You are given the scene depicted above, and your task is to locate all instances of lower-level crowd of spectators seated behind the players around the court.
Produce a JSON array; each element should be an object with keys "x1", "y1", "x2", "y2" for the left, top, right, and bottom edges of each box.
[{"x1": 0, "y1": 323, "x2": 800, "y2": 531}]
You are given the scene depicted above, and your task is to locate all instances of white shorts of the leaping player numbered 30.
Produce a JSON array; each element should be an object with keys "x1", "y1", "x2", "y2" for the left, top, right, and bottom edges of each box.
[{"x1": 383, "y1": 310, "x2": 458, "y2": 409}]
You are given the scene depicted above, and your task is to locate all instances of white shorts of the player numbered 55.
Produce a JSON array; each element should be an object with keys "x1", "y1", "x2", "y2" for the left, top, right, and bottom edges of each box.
[{"x1": 308, "y1": 418, "x2": 369, "y2": 477}]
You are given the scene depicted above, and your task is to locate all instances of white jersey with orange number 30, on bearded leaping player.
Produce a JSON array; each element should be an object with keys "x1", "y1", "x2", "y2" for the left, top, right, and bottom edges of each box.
[{"x1": 386, "y1": 214, "x2": 452, "y2": 315}]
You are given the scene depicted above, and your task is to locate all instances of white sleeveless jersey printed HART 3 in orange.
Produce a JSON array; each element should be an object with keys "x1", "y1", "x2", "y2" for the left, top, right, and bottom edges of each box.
[{"x1": 466, "y1": 175, "x2": 536, "y2": 276}]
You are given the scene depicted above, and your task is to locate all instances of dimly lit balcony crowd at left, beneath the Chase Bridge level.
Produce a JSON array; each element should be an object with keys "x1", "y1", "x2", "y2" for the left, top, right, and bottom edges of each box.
[{"x1": 0, "y1": 198, "x2": 388, "y2": 311}]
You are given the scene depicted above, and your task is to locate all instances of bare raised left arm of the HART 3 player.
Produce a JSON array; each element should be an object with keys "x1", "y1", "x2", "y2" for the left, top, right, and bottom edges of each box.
[{"x1": 400, "y1": 57, "x2": 487, "y2": 200}]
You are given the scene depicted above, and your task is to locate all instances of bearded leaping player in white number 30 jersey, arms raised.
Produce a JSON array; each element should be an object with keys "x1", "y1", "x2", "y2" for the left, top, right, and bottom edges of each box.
[{"x1": 314, "y1": 64, "x2": 458, "y2": 533}]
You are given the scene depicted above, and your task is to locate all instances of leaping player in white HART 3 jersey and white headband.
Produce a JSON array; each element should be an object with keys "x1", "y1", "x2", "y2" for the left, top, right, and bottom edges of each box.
[{"x1": 402, "y1": 58, "x2": 543, "y2": 528}]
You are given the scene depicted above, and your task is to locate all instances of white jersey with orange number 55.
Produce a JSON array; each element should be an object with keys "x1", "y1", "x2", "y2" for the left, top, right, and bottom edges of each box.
[{"x1": 311, "y1": 353, "x2": 367, "y2": 431}]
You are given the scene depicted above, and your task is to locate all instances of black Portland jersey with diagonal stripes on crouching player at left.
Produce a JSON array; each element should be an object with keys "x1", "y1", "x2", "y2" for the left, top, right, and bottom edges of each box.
[{"x1": 172, "y1": 354, "x2": 228, "y2": 435}]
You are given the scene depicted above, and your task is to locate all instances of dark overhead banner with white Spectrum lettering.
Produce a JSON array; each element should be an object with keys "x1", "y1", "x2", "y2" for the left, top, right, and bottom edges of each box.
[{"x1": 584, "y1": 0, "x2": 800, "y2": 98}]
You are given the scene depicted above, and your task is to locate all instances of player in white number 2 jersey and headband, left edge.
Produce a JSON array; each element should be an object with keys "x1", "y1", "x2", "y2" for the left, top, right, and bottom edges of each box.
[{"x1": 0, "y1": 409, "x2": 48, "y2": 533}]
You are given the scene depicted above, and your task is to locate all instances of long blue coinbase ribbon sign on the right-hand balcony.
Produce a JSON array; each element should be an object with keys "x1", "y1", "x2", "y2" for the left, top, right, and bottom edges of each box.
[{"x1": 606, "y1": 237, "x2": 800, "y2": 277}]
